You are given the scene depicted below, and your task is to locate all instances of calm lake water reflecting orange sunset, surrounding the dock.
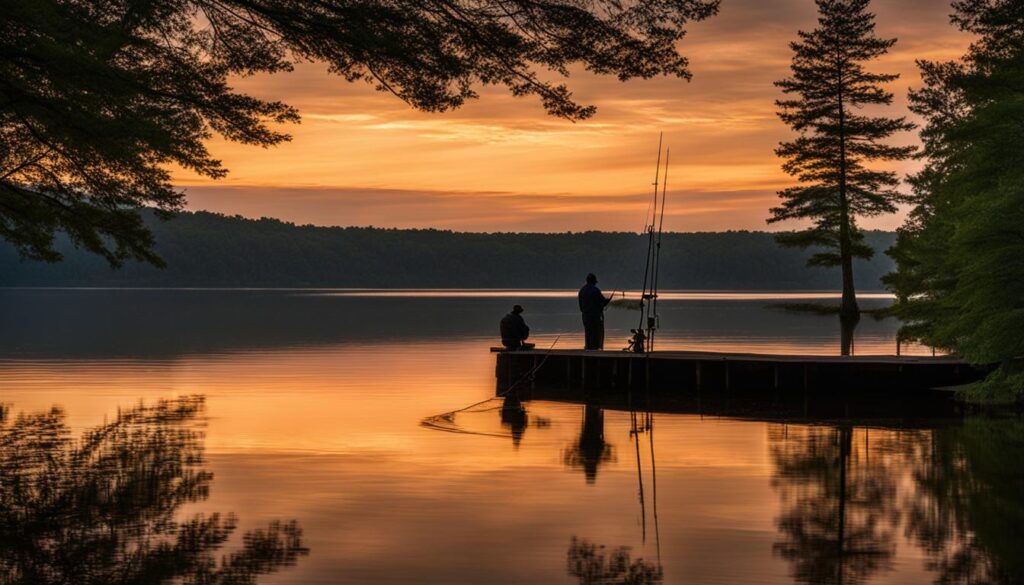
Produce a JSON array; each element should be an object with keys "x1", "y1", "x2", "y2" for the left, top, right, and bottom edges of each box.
[{"x1": 0, "y1": 290, "x2": 1024, "y2": 584}]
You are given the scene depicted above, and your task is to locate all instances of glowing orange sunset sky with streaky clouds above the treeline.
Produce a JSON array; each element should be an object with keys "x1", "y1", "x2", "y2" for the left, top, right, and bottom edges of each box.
[{"x1": 174, "y1": 0, "x2": 969, "y2": 232}]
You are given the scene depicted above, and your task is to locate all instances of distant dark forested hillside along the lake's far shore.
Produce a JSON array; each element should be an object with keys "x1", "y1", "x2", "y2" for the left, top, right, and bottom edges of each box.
[{"x1": 0, "y1": 212, "x2": 895, "y2": 290}]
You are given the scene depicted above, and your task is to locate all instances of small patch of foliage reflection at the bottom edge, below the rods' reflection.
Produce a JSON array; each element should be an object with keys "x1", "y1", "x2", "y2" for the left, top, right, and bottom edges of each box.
[{"x1": 566, "y1": 537, "x2": 665, "y2": 585}]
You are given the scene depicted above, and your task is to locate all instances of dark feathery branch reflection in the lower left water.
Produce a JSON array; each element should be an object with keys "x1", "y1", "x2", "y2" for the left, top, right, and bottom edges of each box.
[{"x1": 0, "y1": 396, "x2": 308, "y2": 585}]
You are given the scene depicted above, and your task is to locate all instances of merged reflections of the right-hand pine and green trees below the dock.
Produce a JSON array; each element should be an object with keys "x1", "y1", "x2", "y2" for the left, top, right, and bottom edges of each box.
[{"x1": 768, "y1": 418, "x2": 1024, "y2": 584}]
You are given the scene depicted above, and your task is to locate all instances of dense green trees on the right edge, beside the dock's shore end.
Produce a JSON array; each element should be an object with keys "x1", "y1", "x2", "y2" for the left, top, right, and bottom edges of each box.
[{"x1": 886, "y1": 0, "x2": 1024, "y2": 402}]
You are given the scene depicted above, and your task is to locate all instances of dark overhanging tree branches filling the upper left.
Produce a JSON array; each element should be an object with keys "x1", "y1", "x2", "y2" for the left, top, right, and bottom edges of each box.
[{"x1": 0, "y1": 0, "x2": 718, "y2": 265}]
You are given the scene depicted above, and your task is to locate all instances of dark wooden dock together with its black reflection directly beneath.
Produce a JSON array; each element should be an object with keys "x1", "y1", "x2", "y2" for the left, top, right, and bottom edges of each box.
[{"x1": 496, "y1": 349, "x2": 984, "y2": 419}]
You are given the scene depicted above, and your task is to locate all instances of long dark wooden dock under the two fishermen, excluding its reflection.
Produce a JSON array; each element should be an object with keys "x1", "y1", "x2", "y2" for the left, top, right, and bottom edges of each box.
[{"x1": 496, "y1": 349, "x2": 982, "y2": 413}]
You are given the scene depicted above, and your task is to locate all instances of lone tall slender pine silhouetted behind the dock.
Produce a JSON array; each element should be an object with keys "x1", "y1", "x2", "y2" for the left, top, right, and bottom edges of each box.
[{"x1": 768, "y1": 0, "x2": 913, "y2": 318}]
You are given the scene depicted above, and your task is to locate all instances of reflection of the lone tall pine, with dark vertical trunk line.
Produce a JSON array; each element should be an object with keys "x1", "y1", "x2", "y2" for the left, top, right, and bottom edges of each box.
[{"x1": 769, "y1": 426, "x2": 895, "y2": 584}]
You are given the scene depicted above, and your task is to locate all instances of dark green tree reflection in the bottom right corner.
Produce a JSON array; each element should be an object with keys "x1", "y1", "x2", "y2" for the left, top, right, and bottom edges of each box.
[{"x1": 906, "y1": 418, "x2": 1024, "y2": 584}]
